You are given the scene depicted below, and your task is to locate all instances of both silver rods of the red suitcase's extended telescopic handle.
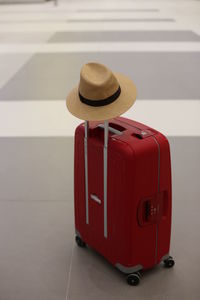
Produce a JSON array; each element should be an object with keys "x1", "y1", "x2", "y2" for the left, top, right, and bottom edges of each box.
[{"x1": 84, "y1": 120, "x2": 109, "y2": 238}]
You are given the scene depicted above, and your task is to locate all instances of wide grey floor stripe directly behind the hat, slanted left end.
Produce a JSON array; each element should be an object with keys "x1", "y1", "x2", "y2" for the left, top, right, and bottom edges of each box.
[{"x1": 0, "y1": 52, "x2": 200, "y2": 101}]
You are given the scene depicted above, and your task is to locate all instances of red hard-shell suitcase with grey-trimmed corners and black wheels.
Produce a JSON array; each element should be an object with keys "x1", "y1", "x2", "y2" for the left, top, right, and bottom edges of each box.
[{"x1": 74, "y1": 117, "x2": 174, "y2": 285}]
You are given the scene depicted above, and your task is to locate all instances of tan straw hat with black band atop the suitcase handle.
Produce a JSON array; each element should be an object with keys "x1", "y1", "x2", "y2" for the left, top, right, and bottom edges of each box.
[{"x1": 66, "y1": 63, "x2": 137, "y2": 121}]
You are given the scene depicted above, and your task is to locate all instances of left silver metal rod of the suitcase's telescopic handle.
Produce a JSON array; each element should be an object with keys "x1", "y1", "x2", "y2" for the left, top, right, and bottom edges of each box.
[{"x1": 84, "y1": 121, "x2": 89, "y2": 224}]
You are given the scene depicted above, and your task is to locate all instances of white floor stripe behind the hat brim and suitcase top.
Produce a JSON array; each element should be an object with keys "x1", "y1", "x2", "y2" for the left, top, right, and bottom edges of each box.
[{"x1": 0, "y1": 100, "x2": 200, "y2": 137}]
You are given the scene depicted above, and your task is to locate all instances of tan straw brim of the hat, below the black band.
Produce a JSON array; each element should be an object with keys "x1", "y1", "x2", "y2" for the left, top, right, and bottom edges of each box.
[{"x1": 66, "y1": 73, "x2": 137, "y2": 121}]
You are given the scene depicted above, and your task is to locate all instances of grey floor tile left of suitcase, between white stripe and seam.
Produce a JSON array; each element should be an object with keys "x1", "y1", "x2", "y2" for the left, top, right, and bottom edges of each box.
[{"x1": 0, "y1": 137, "x2": 73, "y2": 202}]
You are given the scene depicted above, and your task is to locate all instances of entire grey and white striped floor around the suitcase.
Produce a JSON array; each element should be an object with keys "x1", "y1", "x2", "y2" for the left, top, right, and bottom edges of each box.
[{"x1": 0, "y1": 0, "x2": 200, "y2": 300}]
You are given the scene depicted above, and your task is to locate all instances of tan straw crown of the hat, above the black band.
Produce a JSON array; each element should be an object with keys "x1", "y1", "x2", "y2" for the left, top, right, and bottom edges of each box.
[{"x1": 79, "y1": 63, "x2": 119, "y2": 100}]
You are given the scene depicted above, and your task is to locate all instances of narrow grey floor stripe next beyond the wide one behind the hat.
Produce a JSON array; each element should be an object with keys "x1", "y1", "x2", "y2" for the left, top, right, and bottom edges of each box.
[{"x1": 48, "y1": 30, "x2": 200, "y2": 43}]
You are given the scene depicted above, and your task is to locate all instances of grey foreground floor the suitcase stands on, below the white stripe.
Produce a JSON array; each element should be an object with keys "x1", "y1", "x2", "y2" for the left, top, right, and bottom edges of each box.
[{"x1": 0, "y1": 137, "x2": 200, "y2": 300}]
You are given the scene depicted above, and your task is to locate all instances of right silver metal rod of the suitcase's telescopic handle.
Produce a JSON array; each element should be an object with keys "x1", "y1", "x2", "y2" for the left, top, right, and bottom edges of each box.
[{"x1": 103, "y1": 121, "x2": 108, "y2": 238}]
